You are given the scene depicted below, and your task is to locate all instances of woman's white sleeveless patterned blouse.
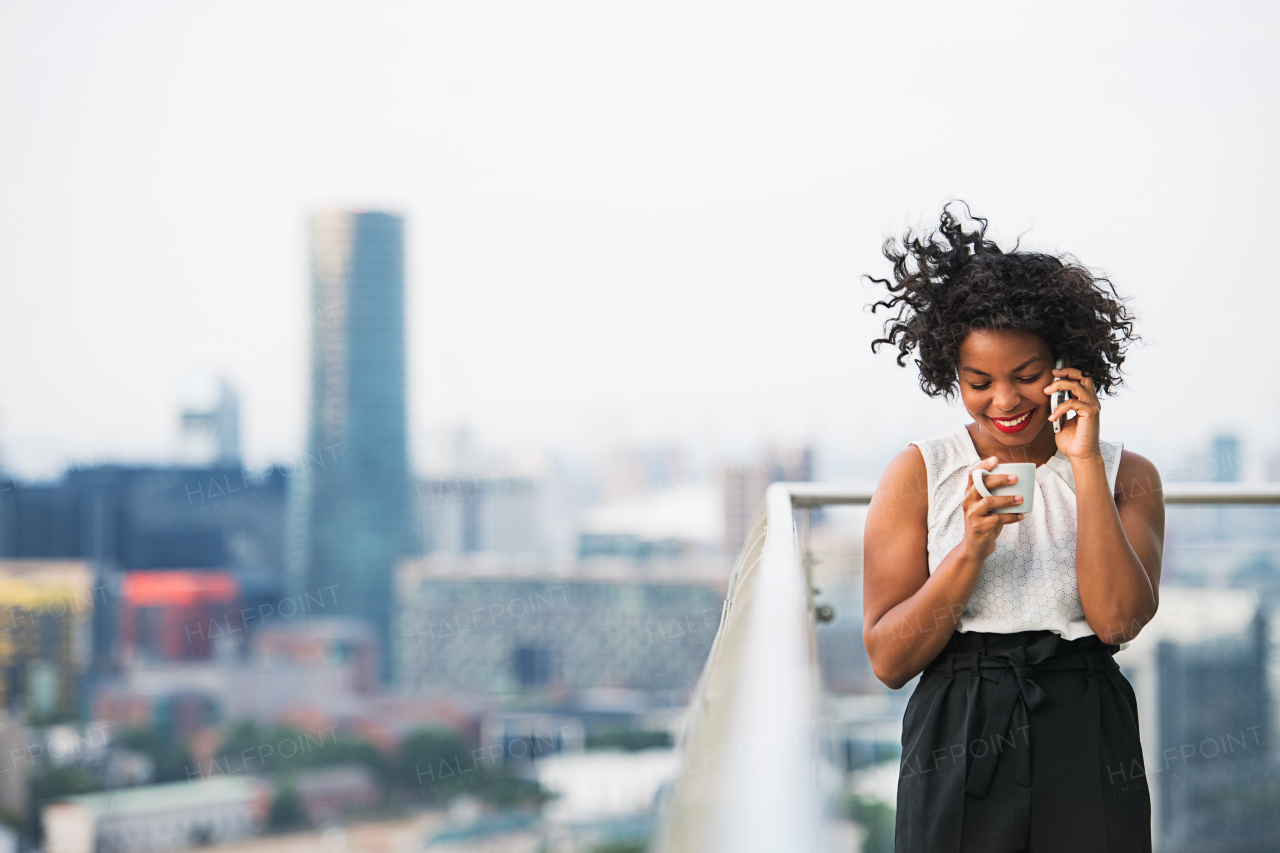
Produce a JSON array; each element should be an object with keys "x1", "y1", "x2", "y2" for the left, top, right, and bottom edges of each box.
[{"x1": 908, "y1": 424, "x2": 1124, "y2": 640}]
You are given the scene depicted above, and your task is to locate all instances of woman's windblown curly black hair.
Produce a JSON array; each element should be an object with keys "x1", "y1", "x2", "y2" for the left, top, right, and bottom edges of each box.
[{"x1": 864, "y1": 201, "x2": 1140, "y2": 400}]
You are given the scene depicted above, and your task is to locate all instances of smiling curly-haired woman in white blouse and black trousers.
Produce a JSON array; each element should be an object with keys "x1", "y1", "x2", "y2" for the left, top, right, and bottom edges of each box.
[{"x1": 863, "y1": 209, "x2": 1165, "y2": 853}]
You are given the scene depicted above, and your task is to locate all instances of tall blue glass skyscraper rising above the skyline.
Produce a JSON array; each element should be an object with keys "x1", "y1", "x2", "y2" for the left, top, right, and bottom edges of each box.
[{"x1": 293, "y1": 211, "x2": 412, "y2": 674}]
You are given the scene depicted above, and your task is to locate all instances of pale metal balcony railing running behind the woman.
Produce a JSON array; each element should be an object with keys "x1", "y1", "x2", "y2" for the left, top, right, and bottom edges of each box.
[{"x1": 650, "y1": 473, "x2": 1280, "y2": 853}]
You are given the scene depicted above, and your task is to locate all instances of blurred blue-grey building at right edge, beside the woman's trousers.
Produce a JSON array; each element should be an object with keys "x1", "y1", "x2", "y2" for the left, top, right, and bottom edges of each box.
[{"x1": 1106, "y1": 587, "x2": 1280, "y2": 853}]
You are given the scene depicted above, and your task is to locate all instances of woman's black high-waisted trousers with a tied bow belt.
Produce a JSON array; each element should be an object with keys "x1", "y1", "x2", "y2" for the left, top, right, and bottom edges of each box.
[{"x1": 895, "y1": 631, "x2": 1151, "y2": 853}]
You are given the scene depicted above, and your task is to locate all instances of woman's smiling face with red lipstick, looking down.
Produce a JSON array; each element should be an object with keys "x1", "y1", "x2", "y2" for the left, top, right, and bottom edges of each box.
[{"x1": 959, "y1": 329, "x2": 1056, "y2": 447}]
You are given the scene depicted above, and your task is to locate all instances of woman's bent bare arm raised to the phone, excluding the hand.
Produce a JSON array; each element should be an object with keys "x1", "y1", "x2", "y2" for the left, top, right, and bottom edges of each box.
[{"x1": 1071, "y1": 451, "x2": 1165, "y2": 643}]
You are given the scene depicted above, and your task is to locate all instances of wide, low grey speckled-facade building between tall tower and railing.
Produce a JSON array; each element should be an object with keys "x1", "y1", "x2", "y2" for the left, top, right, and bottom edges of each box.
[{"x1": 396, "y1": 555, "x2": 726, "y2": 704}]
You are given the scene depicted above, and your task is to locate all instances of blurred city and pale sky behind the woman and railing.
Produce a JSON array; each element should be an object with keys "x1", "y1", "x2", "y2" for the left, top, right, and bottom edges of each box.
[{"x1": 0, "y1": 4, "x2": 1280, "y2": 853}]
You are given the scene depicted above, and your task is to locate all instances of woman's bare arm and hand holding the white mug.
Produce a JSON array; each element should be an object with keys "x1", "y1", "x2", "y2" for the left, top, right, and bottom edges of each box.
[{"x1": 863, "y1": 446, "x2": 1023, "y2": 690}]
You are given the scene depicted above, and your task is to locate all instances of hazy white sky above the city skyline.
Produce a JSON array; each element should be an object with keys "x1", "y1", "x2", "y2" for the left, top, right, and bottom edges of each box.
[{"x1": 0, "y1": 0, "x2": 1280, "y2": 473}]
